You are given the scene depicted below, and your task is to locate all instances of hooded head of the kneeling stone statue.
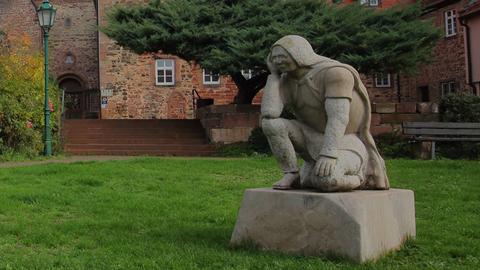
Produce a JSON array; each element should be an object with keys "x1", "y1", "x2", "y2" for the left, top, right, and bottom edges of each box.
[{"x1": 268, "y1": 35, "x2": 329, "y2": 73}]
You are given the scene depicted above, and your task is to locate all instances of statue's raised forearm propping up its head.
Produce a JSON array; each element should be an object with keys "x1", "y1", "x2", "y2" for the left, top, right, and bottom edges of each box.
[{"x1": 260, "y1": 74, "x2": 284, "y2": 119}]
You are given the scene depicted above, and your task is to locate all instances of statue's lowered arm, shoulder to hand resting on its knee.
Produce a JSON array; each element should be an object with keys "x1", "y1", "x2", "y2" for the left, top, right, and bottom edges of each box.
[{"x1": 315, "y1": 68, "x2": 354, "y2": 176}]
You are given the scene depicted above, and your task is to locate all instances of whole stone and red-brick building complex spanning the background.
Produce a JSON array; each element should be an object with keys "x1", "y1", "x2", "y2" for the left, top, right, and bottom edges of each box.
[{"x1": 0, "y1": 0, "x2": 480, "y2": 119}]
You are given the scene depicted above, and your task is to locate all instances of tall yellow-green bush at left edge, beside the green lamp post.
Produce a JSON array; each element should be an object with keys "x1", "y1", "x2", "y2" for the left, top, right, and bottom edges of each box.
[{"x1": 0, "y1": 33, "x2": 59, "y2": 157}]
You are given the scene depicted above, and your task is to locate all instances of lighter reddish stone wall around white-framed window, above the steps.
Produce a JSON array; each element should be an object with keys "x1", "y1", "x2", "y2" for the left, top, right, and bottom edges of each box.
[{"x1": 99, "y1": 0, "x2": 237, "y2": 119}]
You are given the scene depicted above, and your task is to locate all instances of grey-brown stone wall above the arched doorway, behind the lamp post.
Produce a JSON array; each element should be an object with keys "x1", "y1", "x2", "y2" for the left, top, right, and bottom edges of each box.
[{"x1": 0, "y1": 0, "x2": 98, "y2": 89}]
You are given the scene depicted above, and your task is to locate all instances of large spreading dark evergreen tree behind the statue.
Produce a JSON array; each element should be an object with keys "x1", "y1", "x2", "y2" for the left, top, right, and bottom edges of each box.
[{"x1": 102, "y1": 0, "x2": 440, "y2": 104}]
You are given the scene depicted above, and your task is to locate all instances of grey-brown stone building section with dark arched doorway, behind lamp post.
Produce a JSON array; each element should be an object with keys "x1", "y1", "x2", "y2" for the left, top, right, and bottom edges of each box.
[{"x1": 0, "y1": 0, "x2": 100, "y2": 118}]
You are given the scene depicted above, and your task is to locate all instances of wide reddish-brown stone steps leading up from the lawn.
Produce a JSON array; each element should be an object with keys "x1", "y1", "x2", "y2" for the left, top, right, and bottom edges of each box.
[{"x1": 62, "y1": 119, "x2": 215, "y2": 156}]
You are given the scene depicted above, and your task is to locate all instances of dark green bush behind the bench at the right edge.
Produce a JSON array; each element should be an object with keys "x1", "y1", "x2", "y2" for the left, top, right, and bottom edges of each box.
[{"x1": 439, "y1": 93, "x2": 480, "y2": 122}]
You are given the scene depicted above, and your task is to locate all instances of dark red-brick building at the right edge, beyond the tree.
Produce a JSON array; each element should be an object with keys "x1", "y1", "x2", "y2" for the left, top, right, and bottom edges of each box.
[{"x1": 401, "y1": 0, "x2": 480, "y2": 102}]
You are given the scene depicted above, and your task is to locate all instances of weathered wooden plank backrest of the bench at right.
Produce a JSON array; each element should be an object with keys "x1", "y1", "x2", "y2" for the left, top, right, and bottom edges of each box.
[{"x1": 403, "y1": 122, "x2": 480, "y2": 139}]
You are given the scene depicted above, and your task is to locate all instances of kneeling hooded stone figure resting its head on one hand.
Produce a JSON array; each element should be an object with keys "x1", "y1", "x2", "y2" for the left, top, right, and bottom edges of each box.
[{"x1": 261, "y1": 35, "x2": 389, "y2": 192}]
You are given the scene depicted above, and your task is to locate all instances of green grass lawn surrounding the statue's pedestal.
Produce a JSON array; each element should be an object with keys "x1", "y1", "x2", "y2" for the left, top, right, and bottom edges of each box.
[{"x1": 0, "y1": 158, "x2": 480, "y2": 270}]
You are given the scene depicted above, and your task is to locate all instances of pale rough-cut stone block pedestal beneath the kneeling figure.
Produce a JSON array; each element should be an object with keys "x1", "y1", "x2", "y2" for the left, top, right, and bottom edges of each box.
[{"x1": 230, "y1": 188, "x2": 415, "y2": 262}]
